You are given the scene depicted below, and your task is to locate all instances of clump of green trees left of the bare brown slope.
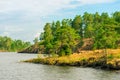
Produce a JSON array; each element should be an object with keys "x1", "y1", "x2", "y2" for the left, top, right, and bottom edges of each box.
[{"x1": 43, "y1": 19, "x2": 79, "y2": 56}]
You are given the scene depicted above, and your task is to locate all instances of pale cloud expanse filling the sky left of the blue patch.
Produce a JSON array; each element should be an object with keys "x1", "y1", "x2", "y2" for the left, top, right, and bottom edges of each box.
[{"x1": 0, "y1": 0, "x2": 116, "y2": 40}]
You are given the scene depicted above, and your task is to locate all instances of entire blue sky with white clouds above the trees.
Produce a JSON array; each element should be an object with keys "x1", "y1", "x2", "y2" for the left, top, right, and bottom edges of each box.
[{"x1": 0, "y1": 0, "x2": 120, "y2": 42}]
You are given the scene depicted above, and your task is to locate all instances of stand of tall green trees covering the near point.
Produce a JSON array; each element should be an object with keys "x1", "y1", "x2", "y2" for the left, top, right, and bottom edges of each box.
[{"x1": 35, "y1": 11, "x2": 120, "y2": 55}]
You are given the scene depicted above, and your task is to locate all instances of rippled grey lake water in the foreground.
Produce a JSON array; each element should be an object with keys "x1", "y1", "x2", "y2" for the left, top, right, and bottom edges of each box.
[{"x1": 0, "y1": 53, "x2": 120, "y2": 80}]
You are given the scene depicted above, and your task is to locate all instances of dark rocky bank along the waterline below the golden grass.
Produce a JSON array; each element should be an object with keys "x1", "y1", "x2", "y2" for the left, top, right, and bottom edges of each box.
[{"x1": 24, "y1": 58, "x2": 120, "y2": 70}]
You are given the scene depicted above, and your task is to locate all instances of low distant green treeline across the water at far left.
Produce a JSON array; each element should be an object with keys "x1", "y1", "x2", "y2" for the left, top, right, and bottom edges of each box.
[{"x1": 0, "y1": 36, "x2": 31, "y2": 51}]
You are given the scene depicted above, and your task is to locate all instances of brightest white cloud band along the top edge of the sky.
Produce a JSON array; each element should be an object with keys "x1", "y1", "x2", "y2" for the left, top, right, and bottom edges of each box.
[{"x1": 0, "y1": 0, "x2": 115, "y2": 16}]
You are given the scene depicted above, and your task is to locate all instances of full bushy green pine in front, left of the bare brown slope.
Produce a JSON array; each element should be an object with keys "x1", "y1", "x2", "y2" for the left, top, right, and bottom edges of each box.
[{"x1": 54, "y1": 24, "x2": 79, "y2": 55}]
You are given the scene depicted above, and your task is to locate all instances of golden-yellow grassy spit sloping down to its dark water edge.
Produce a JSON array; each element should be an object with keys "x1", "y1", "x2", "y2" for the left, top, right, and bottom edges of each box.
[{"x1": 24, "y1": 49, "x2": 120, "y2": 69}]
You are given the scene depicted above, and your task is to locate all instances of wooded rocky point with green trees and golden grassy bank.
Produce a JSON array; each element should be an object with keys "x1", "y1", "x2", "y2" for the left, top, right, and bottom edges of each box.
[{"x1": 21, "y1": 11, "x2": 120, "y2": 70}]
